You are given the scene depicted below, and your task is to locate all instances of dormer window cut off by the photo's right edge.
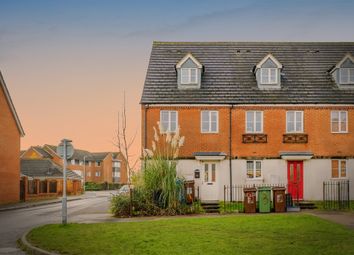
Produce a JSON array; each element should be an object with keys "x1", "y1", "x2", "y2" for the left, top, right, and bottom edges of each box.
[{"x1": 330, "y1": 53, "x2": 354, "y2": 89}]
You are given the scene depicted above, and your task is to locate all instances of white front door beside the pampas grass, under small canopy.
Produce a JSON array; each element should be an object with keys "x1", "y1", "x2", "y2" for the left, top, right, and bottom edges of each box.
[{"x1": 200, "y1": 162, "x2": 218, "y2": 201}]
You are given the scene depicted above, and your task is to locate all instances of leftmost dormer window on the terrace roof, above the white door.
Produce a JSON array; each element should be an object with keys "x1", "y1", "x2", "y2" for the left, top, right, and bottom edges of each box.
[{"x1": 176, "y1": 53, "x2": 203, "y2": 89}]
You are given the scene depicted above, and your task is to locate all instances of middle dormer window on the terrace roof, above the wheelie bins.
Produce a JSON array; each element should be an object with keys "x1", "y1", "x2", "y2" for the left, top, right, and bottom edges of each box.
[{"x1": 254, "y1": 54, "x2": 283, "y2": 89}]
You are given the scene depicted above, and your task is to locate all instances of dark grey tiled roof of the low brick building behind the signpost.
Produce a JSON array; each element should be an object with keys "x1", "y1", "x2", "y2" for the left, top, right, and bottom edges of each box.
[{"x1": 21, "y1": 159, "x2": 81, "y2": 179}]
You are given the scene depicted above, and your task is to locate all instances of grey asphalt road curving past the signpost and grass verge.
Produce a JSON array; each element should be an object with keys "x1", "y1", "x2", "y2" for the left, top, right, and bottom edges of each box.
[{"x1": 0, "y1": 191, "x2": 113, "y2": 254}]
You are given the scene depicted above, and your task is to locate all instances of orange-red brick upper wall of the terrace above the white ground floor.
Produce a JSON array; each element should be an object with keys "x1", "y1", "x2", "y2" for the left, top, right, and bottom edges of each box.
[{"x1": 142, "y1": 106, "x2": 354, "y2": 157}]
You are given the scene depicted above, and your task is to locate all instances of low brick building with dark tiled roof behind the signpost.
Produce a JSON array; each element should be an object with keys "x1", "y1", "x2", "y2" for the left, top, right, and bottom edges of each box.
[{"x1": 21, "y1": 157, "x2": 82, "y2": 201}]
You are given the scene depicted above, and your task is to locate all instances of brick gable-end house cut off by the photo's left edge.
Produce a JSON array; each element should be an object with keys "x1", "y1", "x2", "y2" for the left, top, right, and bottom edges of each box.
[{"x1": 0, "y1": 72, "x2": 25, "y2": 204}]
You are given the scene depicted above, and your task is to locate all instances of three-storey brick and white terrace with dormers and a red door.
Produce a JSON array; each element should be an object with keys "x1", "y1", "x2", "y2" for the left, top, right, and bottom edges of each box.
[{"x1": 140, "y1": 42, "x2": 354, "y2": 200}]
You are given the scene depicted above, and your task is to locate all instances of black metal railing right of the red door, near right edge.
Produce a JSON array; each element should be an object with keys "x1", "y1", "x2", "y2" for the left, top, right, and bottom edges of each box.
[{"x1": 323, "y1": 180, "x2": 350, "y2": 210}]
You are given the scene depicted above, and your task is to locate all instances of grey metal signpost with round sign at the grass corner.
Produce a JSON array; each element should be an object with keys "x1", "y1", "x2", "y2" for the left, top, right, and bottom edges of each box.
[{"x1": 57, "y1": 139, "x2": 74, "y2": 224}]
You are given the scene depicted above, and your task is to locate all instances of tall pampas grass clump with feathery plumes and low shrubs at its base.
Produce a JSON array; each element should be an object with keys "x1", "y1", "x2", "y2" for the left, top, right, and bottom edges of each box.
[{"x1": 111, "y1": 122, "x2": 192, "y2": 216}]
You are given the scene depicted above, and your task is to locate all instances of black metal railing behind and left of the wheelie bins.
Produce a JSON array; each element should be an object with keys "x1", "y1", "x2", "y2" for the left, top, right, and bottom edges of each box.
[{"x1": 222, "y1": 183, "x2": 287, "y2": 212}]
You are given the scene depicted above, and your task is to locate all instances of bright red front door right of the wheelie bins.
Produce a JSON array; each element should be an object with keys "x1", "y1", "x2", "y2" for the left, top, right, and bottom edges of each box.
[{"x1": 288, "y1": 161, "x2": 304, "y2": 200}]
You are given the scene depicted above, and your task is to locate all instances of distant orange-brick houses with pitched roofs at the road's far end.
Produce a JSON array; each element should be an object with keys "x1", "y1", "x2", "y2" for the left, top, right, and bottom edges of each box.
[{"x1": 21, "y1": 144, "x2": 127, "y2": 184}]
